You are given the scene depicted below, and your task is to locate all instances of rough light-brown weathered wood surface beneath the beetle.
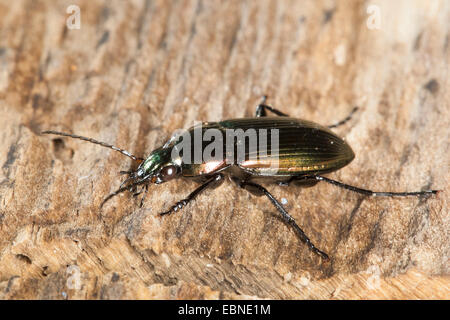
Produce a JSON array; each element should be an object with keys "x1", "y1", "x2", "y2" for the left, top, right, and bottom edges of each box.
[{"x1": 0, "y1": 0, "x2": 450, "y2": 299}]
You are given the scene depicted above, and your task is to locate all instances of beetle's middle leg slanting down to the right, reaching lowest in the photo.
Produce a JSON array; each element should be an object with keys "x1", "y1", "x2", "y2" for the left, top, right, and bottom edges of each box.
[{"x1": 239, "y1": 181, "x2": 330, "y2": 260}]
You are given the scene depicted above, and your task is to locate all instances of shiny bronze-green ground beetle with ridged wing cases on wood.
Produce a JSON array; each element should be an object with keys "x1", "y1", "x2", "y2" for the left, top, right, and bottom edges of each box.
[{"x1": 42, "y1": 96, "x2": 438, "y2": 260}]
